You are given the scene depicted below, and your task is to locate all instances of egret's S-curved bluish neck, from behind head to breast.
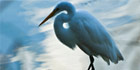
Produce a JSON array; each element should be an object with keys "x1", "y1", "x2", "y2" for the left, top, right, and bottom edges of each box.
[{"x1": 54, "y1": 7, "x2": 76, "y2": 37}]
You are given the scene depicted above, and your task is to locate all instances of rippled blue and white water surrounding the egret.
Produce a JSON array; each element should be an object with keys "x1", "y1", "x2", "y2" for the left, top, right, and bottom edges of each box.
[{"x1": 0, "y1": 0, "x2": 140, "y2": 70}]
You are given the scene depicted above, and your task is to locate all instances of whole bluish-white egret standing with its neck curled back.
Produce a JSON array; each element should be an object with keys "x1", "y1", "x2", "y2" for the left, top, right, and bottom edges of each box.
[{"x1": 39, "y1": 2, "x2": 123, "y2": 70}]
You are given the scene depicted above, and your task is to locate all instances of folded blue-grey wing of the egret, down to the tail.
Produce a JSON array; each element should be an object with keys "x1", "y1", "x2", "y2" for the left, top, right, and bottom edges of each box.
[{"x1": 70, "y1": 13, "x2": 122, "y2": 63}]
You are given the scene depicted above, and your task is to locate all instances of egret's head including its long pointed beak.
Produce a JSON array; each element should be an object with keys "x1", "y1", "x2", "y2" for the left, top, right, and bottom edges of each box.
[{"x1": 39, "y1": 2, "x2": 75, "y2": 26}]
